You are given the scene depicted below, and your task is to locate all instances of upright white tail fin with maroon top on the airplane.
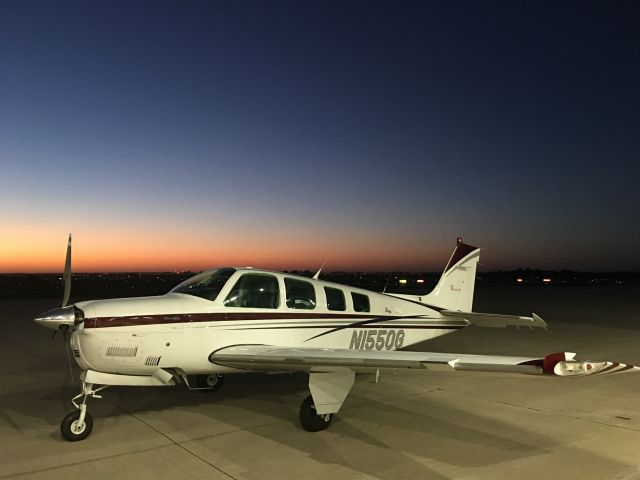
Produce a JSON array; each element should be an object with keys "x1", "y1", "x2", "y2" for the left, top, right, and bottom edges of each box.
[{"x1": 421, "y1": 238, "x2": 480, "y2": 312}]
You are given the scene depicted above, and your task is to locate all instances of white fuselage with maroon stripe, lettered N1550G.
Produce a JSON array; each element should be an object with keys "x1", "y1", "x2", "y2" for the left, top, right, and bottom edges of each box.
[{"x1": 71, "y1": 269, "x2": 468, "y2": 375}]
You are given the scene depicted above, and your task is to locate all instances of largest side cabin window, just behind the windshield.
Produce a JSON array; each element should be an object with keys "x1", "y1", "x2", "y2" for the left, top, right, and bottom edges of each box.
[{"x1": 224, "y1": 273, "x2": 280, "y2": 308}]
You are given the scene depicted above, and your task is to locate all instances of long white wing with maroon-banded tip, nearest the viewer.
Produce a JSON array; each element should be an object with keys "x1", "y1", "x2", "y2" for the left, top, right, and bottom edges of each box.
[{"x1": 209, "y1": 345, "x2": 640, "y2": 377}]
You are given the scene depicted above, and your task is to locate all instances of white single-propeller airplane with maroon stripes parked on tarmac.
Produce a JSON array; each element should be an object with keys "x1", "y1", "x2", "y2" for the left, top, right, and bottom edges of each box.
[{"x1": 34, "y1": 235, "x2": 640, "y2": 441}]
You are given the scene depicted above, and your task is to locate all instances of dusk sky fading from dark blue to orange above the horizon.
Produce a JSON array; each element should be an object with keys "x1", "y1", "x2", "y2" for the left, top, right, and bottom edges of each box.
[{"x1": 0, "y1": 0, "x2": 640, "y2": 273}]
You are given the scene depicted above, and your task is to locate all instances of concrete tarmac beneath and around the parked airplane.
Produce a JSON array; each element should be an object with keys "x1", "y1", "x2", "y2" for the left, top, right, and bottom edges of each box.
[{"x1": 0, "y1": 287, "x2": 640, "y2": 480}]
